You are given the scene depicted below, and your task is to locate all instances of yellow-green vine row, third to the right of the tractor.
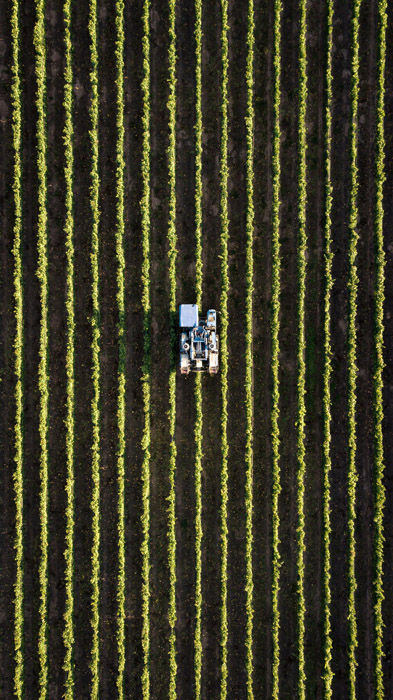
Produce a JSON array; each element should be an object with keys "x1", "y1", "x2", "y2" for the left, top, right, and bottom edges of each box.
[{"x1": 271, "y1": 0, "x2": 282, "y2": 700}]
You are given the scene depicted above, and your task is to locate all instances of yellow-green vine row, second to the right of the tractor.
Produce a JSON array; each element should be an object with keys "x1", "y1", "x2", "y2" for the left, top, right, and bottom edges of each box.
[{"x1": 245, "y1": 0, "x2": 254, "y2": 700}]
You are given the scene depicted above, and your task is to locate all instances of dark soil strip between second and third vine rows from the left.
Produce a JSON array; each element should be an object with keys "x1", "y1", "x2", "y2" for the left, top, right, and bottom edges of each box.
[{"x1": 45, "y1": 0, "x2": 67, "y2": 697}]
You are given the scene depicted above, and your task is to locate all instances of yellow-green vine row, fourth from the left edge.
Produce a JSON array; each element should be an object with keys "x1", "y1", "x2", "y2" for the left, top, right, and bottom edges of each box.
[{"x1": 89, "y1": 0, "x2": 101, "y2": 698}]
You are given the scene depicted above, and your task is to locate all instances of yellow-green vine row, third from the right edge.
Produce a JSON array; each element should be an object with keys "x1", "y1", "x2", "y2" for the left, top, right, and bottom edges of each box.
[{"x1": 322, "y1": 0, "x2": 333, "y2": 700}]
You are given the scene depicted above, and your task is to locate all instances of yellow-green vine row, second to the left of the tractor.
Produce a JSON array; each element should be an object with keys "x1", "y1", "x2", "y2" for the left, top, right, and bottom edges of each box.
[{"x1": 141, "y1": 0, "x2": 151, "y2": 700}]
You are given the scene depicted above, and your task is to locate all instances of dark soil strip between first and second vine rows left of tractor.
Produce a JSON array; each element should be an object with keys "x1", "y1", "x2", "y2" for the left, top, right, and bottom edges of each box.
[{"x1": 150, "y1": 4, "x2": 171, "y2": 698}]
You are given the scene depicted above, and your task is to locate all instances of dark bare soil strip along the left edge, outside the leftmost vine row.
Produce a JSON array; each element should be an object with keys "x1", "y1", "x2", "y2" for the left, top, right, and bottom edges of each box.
[{"x1": 0, "y1": 5, "x2": 16, "y2": 697}]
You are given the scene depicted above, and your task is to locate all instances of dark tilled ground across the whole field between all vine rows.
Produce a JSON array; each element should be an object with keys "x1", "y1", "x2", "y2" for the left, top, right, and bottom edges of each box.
[{"x1": 0, "y1": 0, "x2": 393, "y2": 700}]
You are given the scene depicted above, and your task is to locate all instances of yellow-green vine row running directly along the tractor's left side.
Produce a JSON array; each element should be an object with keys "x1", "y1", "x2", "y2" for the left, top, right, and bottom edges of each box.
[{"x1": 167, "y1": 0, "x2": 177, "y2": 700}]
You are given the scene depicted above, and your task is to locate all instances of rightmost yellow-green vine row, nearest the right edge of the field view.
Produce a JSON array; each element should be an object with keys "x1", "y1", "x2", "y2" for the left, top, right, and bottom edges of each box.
[{"x1": 374, "y1": 0, "x2": 387, "y2": 698}]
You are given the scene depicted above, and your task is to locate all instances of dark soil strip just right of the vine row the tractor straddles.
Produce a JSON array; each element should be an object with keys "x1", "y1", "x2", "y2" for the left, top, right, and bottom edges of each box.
[{"x1": 201, "y1": 2, "x2": 221, "y2": 698}]
